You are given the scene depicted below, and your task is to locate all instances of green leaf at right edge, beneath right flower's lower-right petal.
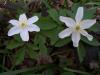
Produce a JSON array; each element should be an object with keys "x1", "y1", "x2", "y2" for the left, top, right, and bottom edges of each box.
[{"x1": 81, "y1": 37, "x2": 100, "y2": 46}]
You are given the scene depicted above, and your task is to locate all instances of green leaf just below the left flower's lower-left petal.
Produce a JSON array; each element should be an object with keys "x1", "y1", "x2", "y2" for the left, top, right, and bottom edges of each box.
[{"x1": 7, "y1": 39, "x2": 24, "y2": 50}]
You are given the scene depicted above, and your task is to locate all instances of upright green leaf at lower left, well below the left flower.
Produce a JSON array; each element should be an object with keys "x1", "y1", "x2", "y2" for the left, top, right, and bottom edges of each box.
[{"x1": 15, "y1": 47, "x2": 26, "y2": 65}]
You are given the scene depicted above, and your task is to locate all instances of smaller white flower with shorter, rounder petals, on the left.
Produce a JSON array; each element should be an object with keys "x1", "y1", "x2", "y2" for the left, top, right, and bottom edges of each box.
[{"x1": 8, "y1": 14, "x2": 40, "y2": 41}]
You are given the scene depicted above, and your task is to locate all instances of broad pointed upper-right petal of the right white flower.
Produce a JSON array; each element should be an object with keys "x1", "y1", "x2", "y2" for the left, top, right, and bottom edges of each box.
[{"x1": 81, "y1": 19, "x2": 96, "y2": 29}]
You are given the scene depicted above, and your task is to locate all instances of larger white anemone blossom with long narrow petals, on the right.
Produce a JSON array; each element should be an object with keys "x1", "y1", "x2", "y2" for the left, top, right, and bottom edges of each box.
[{"x1": 58, "y1": 7, "x2": 96, "y2": 47}]
